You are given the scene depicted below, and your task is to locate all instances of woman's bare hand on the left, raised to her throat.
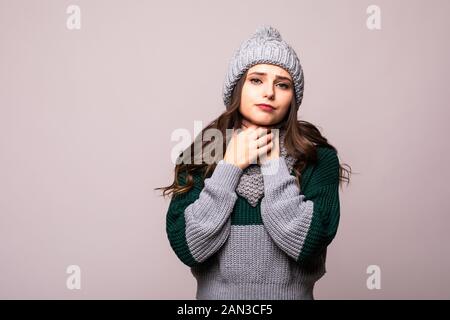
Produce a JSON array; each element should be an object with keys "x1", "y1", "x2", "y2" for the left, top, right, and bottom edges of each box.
[{"x1": 223, "y1": 127, "x2": 273, "y2": 170}]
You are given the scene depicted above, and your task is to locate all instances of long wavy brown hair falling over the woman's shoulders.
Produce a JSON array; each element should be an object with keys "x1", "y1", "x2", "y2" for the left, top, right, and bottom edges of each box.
[{"x1": 154, "y1": 71, "x2": 352, "y2": 197}]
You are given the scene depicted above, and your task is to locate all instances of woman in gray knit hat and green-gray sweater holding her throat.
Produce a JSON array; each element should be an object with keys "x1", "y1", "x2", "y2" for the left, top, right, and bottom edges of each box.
[{"x1": 158, "y1": 26, "x2": 350, "y2": 299}]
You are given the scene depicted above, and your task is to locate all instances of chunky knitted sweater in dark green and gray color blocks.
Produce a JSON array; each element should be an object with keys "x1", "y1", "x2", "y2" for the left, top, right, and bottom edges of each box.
[{"x1": 166, "y1": 146, "x2": 340, "y2": 300}]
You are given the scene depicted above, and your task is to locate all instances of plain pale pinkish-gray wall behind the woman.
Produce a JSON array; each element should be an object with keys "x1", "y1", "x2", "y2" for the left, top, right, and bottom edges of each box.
[{"x1": 0, "y1": 0, "x2": 450, "y2": 299}]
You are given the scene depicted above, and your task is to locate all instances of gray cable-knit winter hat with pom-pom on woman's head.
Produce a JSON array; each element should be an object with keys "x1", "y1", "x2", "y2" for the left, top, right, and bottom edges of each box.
[{"x1": 222, "y1": 25, "x2": 304, "y2": 110}]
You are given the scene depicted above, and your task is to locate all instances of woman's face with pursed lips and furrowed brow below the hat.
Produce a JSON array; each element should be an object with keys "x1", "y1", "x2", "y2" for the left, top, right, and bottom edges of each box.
[{"x1": 239, "y1": 64, "x2": 294, "y2": 127}]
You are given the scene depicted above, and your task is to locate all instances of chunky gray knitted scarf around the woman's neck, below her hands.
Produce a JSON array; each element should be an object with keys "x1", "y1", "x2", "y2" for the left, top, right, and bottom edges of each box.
[{"x1": 236, "y1": 129, "x2": 296, "y2": 207}]
